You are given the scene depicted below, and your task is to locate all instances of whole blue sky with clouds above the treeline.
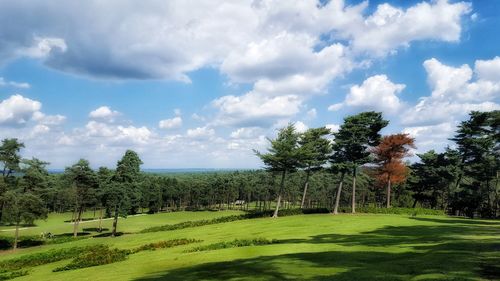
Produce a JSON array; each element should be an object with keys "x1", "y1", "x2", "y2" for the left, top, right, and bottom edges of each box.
[{"x1": 0, "y1": 0, "x2": 500, "y2": 169}]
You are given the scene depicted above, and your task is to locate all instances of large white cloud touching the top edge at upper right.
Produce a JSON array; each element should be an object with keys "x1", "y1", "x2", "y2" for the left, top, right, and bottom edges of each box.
[{"x1": 348, "y1": 0, "x2": 471, "y2": 55}]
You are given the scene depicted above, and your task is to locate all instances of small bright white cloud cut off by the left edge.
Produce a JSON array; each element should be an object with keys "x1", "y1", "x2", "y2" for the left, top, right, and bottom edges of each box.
[{"x1": 0, "y1": 94, "x2": 42, "y2": 126}]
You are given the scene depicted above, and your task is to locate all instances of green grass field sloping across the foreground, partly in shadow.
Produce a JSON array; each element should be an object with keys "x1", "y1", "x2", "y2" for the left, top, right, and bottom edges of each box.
[{"x1": 0, "y1": 211, "x2": 500, "y2": 281}]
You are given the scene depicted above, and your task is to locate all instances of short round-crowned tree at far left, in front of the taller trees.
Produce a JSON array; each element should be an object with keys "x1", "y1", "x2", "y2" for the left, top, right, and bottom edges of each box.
[{"x1": 2, "y1": 190, "x2": 47, "y2": 250}]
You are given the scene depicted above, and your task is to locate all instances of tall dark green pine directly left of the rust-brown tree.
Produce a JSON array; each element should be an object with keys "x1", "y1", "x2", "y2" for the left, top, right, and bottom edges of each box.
[{"x1": 330, "y1": 111, "x2": 389, "y2": 214}]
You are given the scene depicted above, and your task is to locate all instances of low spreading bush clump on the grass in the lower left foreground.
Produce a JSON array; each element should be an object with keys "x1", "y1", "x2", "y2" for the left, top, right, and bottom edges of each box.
[{"x1": 53, "y1": 245, "x2": 130, "y2": 272}]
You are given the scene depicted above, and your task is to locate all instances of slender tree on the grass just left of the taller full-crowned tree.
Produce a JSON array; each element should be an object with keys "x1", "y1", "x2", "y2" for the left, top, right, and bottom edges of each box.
[{"x1": 65, "y1": 159, "x2": 98, "y2": 237}]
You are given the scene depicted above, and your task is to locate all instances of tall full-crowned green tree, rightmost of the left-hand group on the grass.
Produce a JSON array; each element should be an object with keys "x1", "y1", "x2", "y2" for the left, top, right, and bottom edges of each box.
[{"x1": 104, "y1": 150, "x2": 142, "y2": 237}]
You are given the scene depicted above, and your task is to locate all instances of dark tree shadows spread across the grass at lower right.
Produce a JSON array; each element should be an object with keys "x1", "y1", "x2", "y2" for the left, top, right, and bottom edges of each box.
[{"x1": 137, "y1": 215, "x2": 500, "y2": 281}]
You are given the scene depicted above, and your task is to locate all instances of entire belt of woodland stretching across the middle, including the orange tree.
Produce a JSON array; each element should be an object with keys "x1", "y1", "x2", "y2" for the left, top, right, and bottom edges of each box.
[{"x1": 0, "y1": 111, "x2": 500, "y2": 247}]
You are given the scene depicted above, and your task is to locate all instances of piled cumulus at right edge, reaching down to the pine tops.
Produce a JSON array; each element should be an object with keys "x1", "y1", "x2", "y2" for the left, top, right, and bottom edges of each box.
[{"x1": 401, "y1": 57, "x2": 500, "y2": 152}]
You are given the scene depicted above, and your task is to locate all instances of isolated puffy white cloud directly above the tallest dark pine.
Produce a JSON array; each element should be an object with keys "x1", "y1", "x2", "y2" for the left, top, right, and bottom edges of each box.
[{"x1": 342, "y1": 75, "x2": 406, "y2": 113}]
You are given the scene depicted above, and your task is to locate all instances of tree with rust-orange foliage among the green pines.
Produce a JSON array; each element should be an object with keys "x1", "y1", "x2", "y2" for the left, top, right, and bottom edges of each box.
[{"x1": 372, "y1": 134, "x2": 416, "y2": 208}]
